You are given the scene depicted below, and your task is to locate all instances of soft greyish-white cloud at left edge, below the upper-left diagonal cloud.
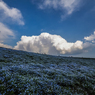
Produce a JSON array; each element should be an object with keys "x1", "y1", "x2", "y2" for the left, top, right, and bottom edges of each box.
[{"x1": 0, "y1": 23, "x2": 15, "y2": 41}]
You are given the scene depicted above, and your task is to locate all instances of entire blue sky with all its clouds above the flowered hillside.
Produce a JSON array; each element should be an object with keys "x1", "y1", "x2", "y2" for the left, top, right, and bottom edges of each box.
[{"x1": 0, "y1": 0, "x2": 95, "y2": 58}]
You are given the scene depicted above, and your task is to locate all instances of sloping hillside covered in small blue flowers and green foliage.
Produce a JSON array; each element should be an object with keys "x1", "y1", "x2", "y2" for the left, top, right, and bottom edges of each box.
[{"x1": 0, "y1": 48, "x2": 95, "y2": 95}]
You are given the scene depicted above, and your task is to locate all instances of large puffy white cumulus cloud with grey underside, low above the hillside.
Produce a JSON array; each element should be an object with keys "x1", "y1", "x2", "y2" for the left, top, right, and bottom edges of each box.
[{"x1": 14, "y1": 33, "x2": 93, "y2": 54}]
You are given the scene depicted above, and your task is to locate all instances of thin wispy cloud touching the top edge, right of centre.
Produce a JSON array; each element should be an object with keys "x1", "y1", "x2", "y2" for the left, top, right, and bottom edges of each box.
[{"x1": 36, "y1": 0, "x2": 81, "y2": 17}]
